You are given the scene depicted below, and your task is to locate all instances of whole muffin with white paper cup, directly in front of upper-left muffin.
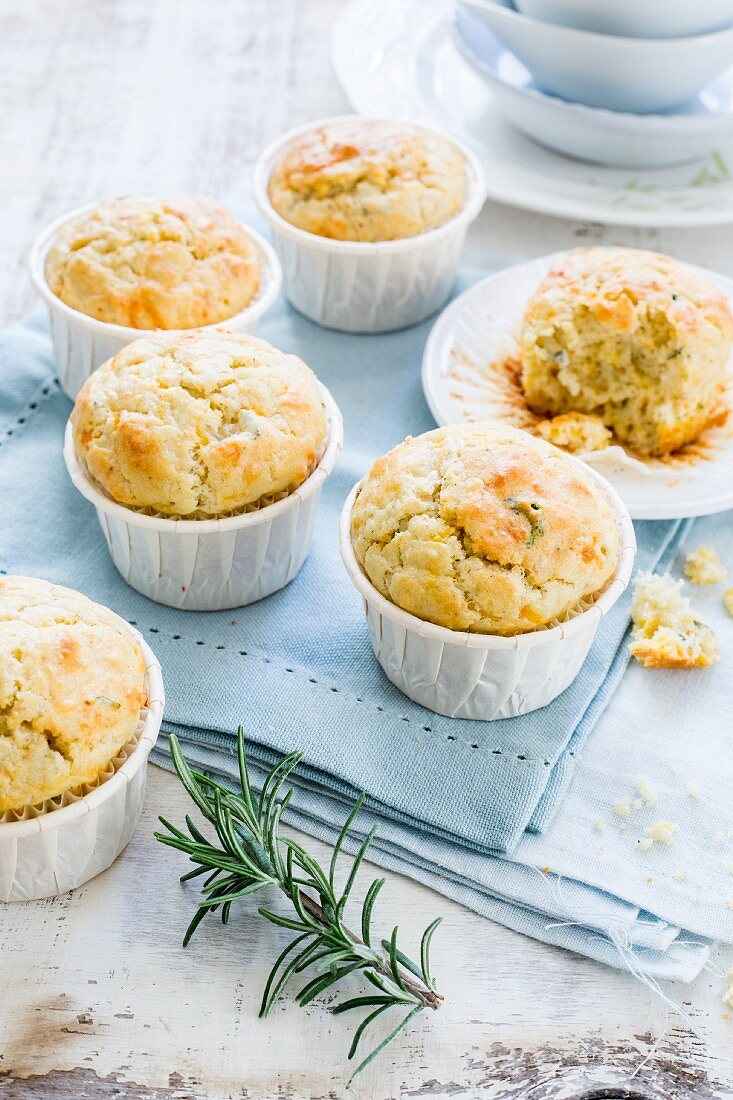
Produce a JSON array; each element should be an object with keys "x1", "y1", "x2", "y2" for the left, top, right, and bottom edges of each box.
[{"x1": 64, "y1": 329, "x2": 342, "y2": 611}]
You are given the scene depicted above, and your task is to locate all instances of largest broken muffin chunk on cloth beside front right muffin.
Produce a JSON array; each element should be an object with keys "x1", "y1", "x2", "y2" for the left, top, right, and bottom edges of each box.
[{"x1": 630, "y1": 573, "x2": 720, "y2": 669}]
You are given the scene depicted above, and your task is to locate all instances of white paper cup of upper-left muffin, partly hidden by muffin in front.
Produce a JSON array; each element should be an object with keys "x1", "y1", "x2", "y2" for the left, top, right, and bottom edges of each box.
[{"x1": 30, "y1": 202, "x2": 283, "y2": 400}]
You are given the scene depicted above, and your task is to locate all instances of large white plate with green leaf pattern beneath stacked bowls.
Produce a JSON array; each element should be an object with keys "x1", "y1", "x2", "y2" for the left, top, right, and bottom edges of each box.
[{"x1": 331, "y1": 0, "x2": 733, "y2": 228}]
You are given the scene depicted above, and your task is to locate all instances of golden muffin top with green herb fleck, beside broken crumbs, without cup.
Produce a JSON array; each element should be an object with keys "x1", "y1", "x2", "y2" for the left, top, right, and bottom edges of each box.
[{"x1": 351, "y1": 424, "x2": 620, "y2": 635}]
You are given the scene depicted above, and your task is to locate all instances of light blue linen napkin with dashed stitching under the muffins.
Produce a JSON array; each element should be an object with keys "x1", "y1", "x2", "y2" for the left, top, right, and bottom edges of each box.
[{"x1": 0, "y1": 288, "x2": 721, "y2": 977}]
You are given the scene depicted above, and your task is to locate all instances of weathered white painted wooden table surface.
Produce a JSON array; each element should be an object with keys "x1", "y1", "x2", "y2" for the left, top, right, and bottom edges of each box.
[{"x1": 0, "y1": 0, "x2": 733, "y2": 1100}]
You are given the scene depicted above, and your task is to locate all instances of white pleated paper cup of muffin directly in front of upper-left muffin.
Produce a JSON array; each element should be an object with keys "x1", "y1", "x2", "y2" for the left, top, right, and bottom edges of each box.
[{"x1": 64, "y1": 386, "x2": 343, "y2": 612}]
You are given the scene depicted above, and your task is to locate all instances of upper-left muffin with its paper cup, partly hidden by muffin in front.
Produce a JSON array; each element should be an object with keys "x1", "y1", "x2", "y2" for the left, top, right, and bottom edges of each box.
[{"x1": 31, "y1": 196, "x2": 281, "y2": 397}]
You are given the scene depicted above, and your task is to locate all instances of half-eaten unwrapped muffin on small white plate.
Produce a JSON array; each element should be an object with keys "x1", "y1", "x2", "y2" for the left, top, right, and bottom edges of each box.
[{"x1": 521, "y1": 248, "x2": 733, "y2": 455}]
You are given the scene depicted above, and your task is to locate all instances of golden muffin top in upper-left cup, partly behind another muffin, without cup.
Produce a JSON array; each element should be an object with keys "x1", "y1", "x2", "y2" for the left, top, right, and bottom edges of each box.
[{"x1": 45, "y1": 197, "x2": 260, "y2": 329}]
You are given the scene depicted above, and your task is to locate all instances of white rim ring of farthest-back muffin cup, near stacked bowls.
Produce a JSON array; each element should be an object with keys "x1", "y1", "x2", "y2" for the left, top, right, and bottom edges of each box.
[{"x1": 252, "y1": 112, "x2": 486, "y2": 256}]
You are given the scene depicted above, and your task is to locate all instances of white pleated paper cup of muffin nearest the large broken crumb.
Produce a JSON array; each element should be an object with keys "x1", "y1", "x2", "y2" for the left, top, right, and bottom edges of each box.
[{"x1": 339, "y1": 468, "x2": 636, "y2": 722}]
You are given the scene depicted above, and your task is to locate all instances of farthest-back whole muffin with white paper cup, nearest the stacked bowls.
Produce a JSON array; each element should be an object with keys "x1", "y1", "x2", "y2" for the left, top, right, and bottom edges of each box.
[{"x1": 254, "y1": 116, "x2": 484, "y2": 332}]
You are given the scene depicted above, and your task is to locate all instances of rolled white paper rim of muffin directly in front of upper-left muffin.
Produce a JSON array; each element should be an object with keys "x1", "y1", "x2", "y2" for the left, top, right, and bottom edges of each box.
[{"x1": 64, "y1": 385, "x2": 343, "y2": 535}]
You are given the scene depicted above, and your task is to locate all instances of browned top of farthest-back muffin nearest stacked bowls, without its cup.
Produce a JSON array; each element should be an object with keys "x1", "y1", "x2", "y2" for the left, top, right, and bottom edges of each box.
[{"x1": 269, "y1": 118, "x2": 467, "y2": 242}]
